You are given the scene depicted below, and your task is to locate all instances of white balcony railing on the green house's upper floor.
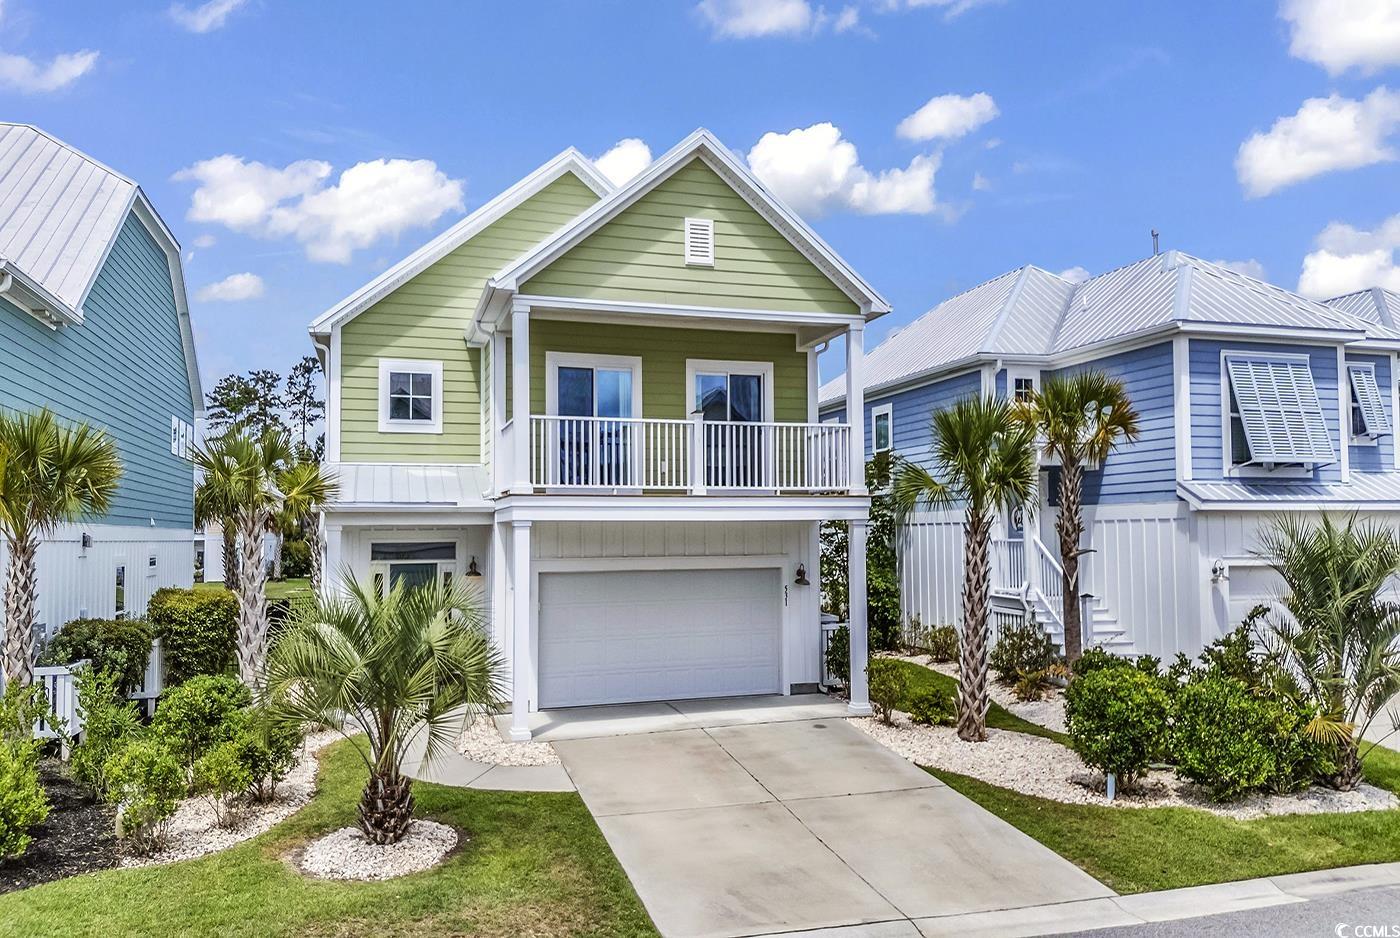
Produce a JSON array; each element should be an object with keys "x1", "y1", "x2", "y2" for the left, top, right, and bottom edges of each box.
[{"x1": 531, "y1": 414, "x2": 851, "y2": 493}]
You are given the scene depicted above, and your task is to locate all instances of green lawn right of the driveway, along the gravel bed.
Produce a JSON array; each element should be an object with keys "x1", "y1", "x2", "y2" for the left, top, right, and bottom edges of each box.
[{"x1": 902, "y1": 662, "x2": 1400, "y2": 893}]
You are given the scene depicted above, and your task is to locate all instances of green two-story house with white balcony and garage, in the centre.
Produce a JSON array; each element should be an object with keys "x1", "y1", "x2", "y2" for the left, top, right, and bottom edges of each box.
[{"x1": 311, "y1": 130, "x2": 889, "y2": 739}]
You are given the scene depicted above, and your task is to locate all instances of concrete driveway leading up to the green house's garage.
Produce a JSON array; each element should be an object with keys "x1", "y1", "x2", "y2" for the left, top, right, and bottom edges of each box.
[{"x1": 554, "y1": 718, "x2": 1113, "y2": 938}]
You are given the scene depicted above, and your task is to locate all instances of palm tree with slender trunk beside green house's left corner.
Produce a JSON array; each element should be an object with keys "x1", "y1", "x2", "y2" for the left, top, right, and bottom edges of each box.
[{"x1": 195, "y1": 428, "x2": 333, "y2": 689}]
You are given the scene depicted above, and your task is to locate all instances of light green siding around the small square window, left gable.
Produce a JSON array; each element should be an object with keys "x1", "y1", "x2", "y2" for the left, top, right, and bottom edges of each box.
[{"x1": 340, "y1": 174, "x2": 598, "y2": 462}]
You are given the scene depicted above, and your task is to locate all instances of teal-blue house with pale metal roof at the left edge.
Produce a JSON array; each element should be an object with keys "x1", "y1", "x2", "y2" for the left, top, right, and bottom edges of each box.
[{"x1": 0, "y1": 123, "x2": 203, "y2": 644}]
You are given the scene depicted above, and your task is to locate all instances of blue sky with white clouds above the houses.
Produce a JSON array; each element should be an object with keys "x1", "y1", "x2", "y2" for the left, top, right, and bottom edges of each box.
[{"x1": 0, "y1": 0, "x2": 1400, "y2": 384}]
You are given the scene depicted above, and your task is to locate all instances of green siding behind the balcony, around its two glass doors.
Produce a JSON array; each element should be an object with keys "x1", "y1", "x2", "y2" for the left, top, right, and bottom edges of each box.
[{"x1": 526, "y1": 319, "x2": 808, "y2": 423}]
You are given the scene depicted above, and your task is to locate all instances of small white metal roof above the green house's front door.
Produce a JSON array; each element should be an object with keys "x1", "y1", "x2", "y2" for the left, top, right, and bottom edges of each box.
[{"x1": 328, "y1": 462, "x2": 490, "y2": 510}]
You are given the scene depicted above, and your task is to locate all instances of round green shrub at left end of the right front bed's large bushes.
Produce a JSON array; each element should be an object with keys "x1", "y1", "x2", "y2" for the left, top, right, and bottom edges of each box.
[{"x1": 1064, "y1": 666, "x2": 1168, "y2": 788}]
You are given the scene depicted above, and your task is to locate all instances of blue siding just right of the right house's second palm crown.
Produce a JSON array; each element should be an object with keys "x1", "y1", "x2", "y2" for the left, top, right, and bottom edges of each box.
[{"x1": 1054, "y1": 342, "x2": 1176, "y2": 504}]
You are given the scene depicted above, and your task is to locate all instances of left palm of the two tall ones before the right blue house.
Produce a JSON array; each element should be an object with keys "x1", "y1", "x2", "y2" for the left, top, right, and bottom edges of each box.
[{"x1": 895, "y1": 396, "x2": 1036, "y2": 742}]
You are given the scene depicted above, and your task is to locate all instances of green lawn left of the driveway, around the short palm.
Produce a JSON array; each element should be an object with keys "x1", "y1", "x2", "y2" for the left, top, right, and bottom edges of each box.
[{"x1": 0, "y1": 742, "x2": 657, "y2": 938}]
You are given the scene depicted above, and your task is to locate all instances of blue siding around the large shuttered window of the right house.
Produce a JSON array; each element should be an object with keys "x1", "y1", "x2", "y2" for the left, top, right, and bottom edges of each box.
[{"x1": 1190, "y1": 339, "x2": 1341, "y2": 482}]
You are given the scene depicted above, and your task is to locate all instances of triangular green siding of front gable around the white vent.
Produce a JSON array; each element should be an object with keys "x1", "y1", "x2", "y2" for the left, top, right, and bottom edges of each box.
[{"x1": 521, "y1": 158, "x2": 860, "y2": 314}]
